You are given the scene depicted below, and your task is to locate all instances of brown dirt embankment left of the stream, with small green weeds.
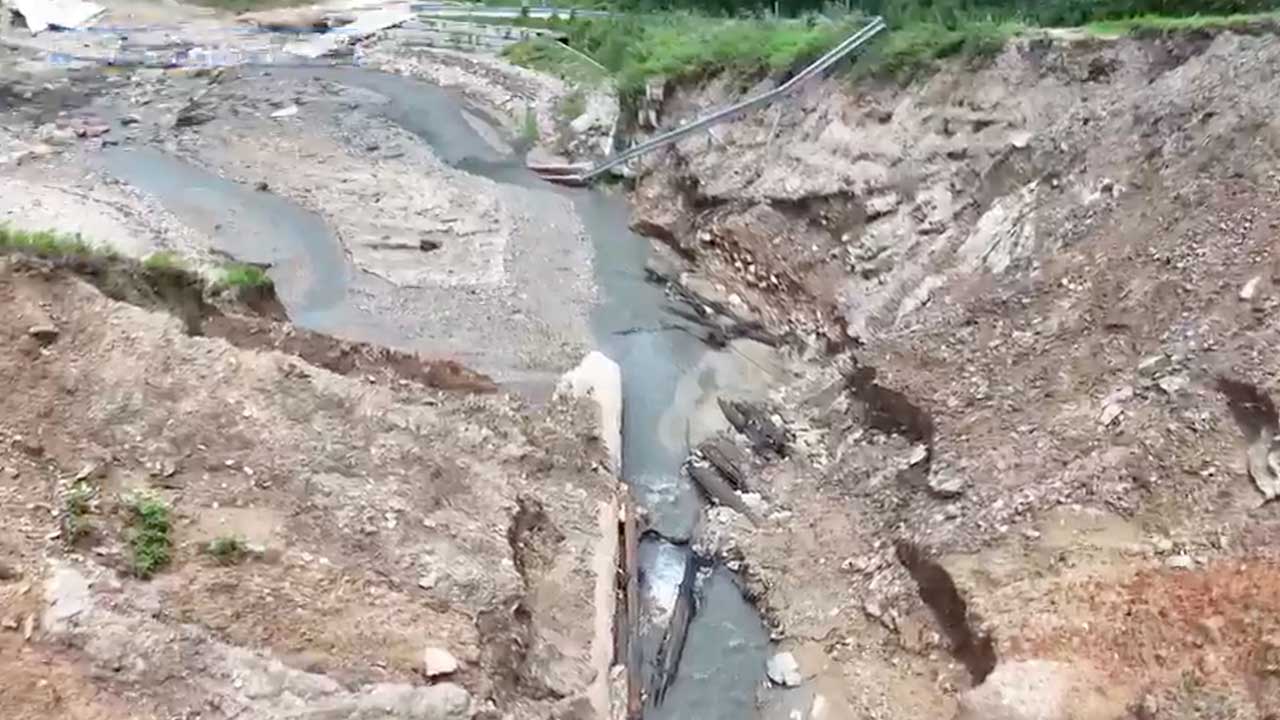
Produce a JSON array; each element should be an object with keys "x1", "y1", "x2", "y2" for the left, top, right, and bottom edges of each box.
[{"x1": 0, "y1": 258, "x2": 614, "y2": 720}]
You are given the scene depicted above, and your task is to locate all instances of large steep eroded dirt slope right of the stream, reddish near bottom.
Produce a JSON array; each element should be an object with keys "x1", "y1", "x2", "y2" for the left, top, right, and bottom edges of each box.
[{"x1": 634, "y1": 33, "x2": 1280, "y2": 717}]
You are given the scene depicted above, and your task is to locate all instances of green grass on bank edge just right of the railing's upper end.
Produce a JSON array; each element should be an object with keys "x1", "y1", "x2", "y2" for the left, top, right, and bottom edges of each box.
[{"x1": 854, "y1": 20, "x2": 1023, "y2": 85}]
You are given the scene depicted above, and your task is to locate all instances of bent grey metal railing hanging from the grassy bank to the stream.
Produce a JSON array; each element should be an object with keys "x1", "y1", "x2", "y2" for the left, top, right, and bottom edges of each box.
[{"x1": 530, "y1": 17, "x2": 886, "y2": 184}]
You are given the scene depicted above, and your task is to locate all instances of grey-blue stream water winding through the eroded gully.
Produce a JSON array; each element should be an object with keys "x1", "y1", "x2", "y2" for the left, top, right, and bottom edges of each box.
[{"x1": 104, "y1": 68, "x2": 771, "y2": 720}]
